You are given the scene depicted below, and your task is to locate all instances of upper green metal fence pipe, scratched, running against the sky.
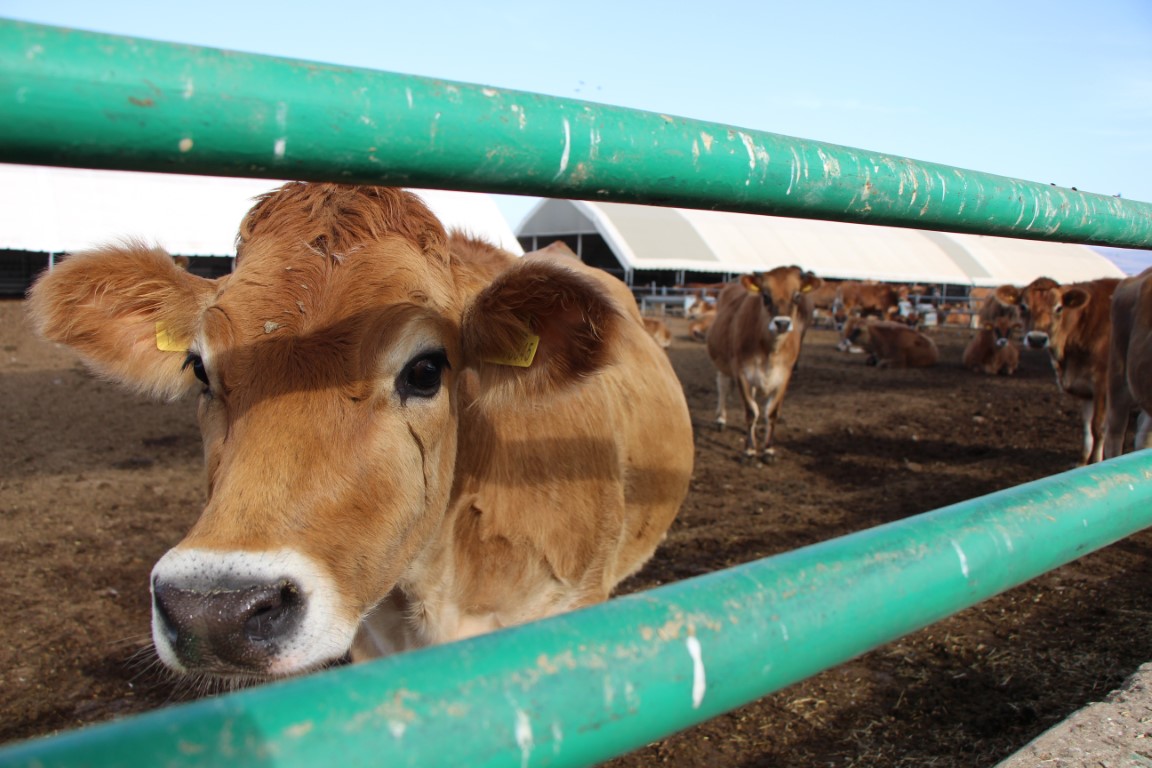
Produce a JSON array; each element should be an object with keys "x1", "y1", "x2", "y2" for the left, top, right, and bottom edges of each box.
[{"x1": 0, "y1": 21, "x2": 1152, "y2": 248}]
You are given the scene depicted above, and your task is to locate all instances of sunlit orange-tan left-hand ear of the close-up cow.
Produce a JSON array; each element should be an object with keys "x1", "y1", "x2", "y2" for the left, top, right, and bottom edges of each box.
[{"x1": 28, "y1": 243, "x2": 219, "y2": 400}]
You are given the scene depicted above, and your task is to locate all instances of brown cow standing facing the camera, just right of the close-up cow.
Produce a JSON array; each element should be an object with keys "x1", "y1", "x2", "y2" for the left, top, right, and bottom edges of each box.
[{"x1": 707, "y1": 266, "x2": 824, "y2": 458}]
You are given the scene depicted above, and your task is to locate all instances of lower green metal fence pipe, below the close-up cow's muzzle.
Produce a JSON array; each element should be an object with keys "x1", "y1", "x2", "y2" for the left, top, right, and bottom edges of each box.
[{"x1": 0, "y1": 451, "x2": 1152, "y2": 768}]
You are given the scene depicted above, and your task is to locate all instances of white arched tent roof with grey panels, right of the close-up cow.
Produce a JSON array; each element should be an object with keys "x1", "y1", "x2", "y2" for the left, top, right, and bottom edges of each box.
[{"x1": 517, "y1": 199, "x2": 1123, "y2": 286}]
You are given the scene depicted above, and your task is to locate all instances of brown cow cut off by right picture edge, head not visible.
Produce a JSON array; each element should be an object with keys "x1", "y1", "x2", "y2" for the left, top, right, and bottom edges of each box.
[{"x1": 1104, "y1": 268, "x2": 1152, "y2": 458}]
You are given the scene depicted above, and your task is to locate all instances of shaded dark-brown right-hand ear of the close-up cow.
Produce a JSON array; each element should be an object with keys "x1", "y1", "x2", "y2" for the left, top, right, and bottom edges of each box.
[{"x1": 461, "y1": 260, "x2": 623, "y2": 403}]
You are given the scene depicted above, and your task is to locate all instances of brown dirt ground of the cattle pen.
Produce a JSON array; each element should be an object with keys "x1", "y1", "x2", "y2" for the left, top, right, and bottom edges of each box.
[{"x1": 0, "y1": 302, "x2": 1152, "y2": 768}]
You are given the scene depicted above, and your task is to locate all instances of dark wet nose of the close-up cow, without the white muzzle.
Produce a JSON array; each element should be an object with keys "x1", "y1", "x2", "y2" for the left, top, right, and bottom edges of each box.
[{"x1": 152, "y1": 579, "x2": 304, "y2": 671}]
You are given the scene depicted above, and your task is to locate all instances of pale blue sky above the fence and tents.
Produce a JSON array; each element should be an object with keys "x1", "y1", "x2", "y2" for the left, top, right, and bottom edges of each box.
[{"x1": 0, "y1": 0, "x2": 1152, "y2": 234}]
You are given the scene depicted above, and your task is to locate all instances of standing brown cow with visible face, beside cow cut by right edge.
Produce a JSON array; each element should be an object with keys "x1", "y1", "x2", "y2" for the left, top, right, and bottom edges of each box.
[{"x1": 1021, "y1": 277, "x2": 1120, "y2": 464}]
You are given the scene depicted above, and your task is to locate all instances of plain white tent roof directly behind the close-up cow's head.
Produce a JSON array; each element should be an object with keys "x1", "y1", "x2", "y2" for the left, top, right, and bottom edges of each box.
[{"x1": 0, "y1": 164, "x2": 524, "y2": 256}]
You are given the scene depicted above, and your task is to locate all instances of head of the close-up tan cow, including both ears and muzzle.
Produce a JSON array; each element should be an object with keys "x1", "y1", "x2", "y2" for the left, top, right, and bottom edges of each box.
[{"x1": 30, "y1": 183, "x2": 617, "y2": 678}]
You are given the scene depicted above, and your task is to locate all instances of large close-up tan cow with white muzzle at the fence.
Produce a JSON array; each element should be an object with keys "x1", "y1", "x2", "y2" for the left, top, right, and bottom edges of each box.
[{"x1": 31, "y1": 183, "x2": 692, "y2": 679}]
